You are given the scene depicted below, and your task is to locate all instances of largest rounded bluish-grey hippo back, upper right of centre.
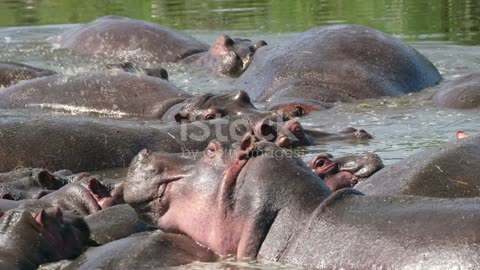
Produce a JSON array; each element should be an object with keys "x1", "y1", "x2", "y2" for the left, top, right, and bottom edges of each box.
[{"x1": 234, "y1": 25, "x2": 442, "y2": 113}]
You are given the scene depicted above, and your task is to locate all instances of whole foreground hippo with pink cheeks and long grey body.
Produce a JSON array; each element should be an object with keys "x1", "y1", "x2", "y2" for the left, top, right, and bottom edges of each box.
[{"x1": 123, "y1": 135, "x2": 480, "y2": 269}]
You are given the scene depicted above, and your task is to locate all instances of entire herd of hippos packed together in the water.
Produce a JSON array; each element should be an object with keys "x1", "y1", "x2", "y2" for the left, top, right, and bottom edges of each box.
[{"x1": 0, "y1": 16, "x2": 480, "y2": 269}]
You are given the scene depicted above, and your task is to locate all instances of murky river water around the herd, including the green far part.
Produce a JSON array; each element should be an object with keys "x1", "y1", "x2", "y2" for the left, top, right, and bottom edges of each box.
[{"x1": 0, "y1": 1, "x2": 480, "y2": 269}]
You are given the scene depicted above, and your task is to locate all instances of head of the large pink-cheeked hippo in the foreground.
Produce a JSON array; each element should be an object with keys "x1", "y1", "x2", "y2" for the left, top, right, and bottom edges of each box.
[{"x1": 124, "y1": 135, "x2": 330, "y2": 258}]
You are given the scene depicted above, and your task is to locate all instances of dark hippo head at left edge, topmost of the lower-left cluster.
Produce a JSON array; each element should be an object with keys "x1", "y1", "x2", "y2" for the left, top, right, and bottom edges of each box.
[{"x1": 0, "y1": 168, "x2": 68, "y2": 200}]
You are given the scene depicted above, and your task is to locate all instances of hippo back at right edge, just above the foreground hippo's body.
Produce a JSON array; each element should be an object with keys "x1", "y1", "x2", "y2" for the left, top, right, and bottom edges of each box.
[{"x1": 355, "y1": 136, "x2": 480, "y2": 198}]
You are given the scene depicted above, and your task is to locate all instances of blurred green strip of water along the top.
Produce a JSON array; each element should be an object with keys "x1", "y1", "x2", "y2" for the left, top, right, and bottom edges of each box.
[{"x1": 0, "y1": 0, "x2": 480, "y2": 45}]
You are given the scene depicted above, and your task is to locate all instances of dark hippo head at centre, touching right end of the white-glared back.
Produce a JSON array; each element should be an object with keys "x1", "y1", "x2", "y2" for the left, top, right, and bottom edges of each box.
[{"x1": 162, "y1": 91, "x2": 273, "y2": 123}]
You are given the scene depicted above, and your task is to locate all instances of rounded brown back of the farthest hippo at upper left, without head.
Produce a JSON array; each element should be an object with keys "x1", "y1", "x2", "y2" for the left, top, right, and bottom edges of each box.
[{"x1": 60, "y1": 16, "x2": 208, "y2": 63}]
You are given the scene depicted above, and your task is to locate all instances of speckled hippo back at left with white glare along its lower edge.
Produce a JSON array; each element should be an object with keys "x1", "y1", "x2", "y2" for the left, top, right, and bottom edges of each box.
[{"x1": 0, "y1": 71, "x2": 191, "y2": 117}]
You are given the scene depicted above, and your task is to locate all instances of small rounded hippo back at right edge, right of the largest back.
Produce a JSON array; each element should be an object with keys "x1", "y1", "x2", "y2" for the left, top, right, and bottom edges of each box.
[{"x1": 432, "y1": 73, "x2": 480, "y2": 109}]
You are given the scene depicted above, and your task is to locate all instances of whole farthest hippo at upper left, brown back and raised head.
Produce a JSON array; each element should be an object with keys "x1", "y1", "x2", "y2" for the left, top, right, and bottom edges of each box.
[{"x1": 60, "y1": 16, "x2": 266, "y2": 76}]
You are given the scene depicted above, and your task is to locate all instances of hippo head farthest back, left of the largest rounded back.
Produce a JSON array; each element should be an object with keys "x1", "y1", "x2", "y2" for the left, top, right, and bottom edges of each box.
[{"x1": 205, "y1": 35, "x2": 267, "y2": 77}]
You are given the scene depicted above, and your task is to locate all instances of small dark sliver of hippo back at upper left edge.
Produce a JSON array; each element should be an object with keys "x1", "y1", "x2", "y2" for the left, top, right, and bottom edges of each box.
[{"x1": 0, "y1": 61, "x2": 56, "y2": 87}]
